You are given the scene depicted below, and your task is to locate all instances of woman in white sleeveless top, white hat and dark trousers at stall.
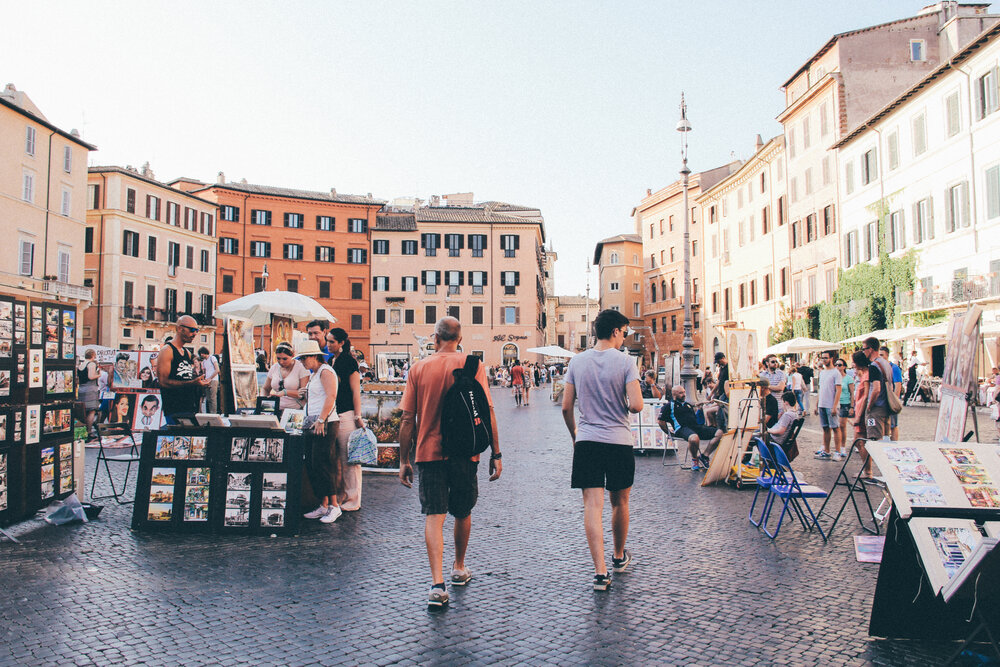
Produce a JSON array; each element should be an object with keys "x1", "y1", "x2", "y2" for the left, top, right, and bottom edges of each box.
[{"x1": 295, "y1": 340, "x2": 343, "y2": 523}]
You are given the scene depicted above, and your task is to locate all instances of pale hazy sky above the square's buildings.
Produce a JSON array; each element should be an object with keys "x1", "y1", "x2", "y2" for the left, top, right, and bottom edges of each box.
[{"x1": 0, "y1": 0, "x2": 924, "y2": 297}]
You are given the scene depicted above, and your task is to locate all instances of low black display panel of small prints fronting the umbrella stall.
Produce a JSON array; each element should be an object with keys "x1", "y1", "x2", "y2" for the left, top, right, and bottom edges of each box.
[{"x1": 132, "y1": 428, "x2": 304, "y2": 534}]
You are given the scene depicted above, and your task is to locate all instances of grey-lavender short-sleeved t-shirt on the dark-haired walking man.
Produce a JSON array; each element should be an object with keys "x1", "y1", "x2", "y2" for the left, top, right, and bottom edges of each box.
[{"x1": 565, "y1": 349, "x2": 639, "y2": 447}]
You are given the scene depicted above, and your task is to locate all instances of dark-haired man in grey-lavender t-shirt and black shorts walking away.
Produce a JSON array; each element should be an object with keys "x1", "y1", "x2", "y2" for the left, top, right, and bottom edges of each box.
[{"x1": 562, "y1": 308, "x2": 643, "y2": 591}]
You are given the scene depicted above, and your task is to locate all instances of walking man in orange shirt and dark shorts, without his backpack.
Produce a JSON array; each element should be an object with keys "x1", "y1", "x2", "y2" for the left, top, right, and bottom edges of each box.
[{"x1": 399, "y1": 317, "x2": 503, "y2": 607}]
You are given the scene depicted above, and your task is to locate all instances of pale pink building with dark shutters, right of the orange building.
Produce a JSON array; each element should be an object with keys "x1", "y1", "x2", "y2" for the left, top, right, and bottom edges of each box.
[{"x1": 371, "y1": 199, "x2": 546, "y2": 364}]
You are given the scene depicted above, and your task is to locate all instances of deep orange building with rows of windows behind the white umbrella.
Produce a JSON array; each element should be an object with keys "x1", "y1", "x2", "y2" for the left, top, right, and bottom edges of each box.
[{"x1": 178, "y1": 174, "x2": 385, "y2": 357}]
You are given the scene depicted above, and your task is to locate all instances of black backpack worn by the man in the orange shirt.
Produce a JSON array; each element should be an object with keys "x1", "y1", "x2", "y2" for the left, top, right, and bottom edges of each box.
[{"x1": 441, "y1": 354, "x2": 493, "y2": 458}]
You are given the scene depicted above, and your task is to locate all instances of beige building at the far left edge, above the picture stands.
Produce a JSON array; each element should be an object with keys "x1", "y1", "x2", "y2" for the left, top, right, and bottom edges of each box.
[{"x1": 0, "y1": 84, "x2": 96, "y2": 306}]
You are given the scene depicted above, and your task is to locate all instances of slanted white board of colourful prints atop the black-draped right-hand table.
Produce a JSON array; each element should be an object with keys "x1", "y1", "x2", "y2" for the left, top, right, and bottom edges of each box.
[{"x1": 867, "y1": 442, "x2": 1000, "y2": 519}]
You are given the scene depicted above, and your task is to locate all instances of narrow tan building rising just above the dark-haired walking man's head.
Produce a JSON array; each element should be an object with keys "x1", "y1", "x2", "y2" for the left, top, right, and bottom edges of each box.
[{"x1": 594, "y1": 234, "x2": 645, "y2": 354}]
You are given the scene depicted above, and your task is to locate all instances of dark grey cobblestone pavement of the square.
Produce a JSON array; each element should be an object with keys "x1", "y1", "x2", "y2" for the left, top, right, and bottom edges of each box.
[{"x1": 0, "y1": 390, "x2": 996, "y2": 665}]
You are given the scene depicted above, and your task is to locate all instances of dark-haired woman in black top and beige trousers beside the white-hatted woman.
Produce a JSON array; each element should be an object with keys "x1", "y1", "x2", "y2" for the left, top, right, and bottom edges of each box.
[{"x1": 326, "y1": 327, "x2": 365, "y2": 512}]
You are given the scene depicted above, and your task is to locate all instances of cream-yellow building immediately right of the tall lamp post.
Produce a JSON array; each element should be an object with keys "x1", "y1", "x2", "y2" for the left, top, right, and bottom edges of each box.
[{"x1": 697, "y1": 135, "x2": 790, "y2": 354}]
